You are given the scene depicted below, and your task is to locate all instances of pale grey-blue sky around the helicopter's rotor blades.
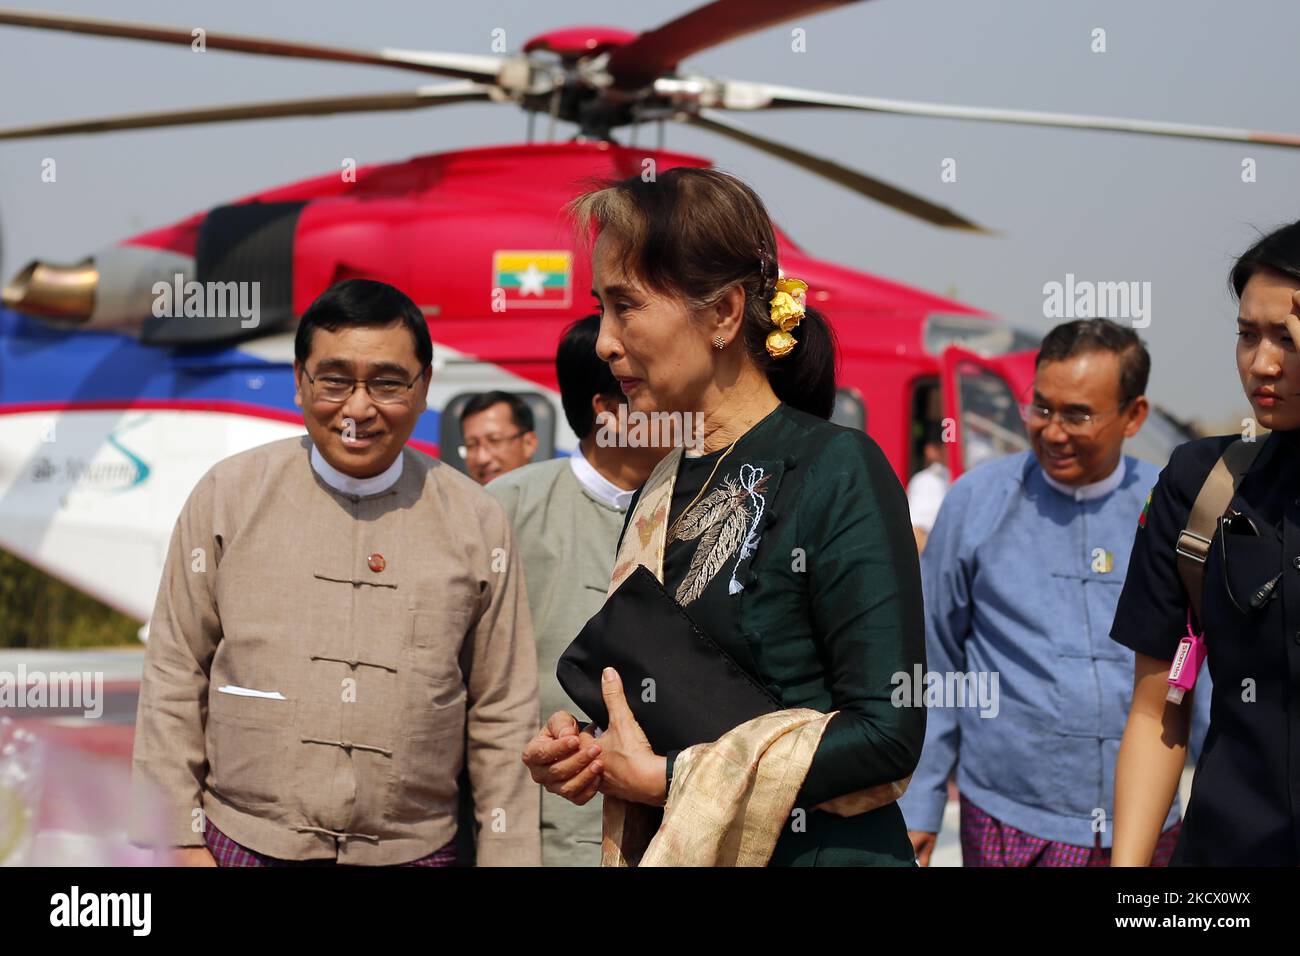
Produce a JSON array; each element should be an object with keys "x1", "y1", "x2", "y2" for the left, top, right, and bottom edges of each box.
[{"x1": 0, "y1": 0, "x2": 1300, "y2": 423}]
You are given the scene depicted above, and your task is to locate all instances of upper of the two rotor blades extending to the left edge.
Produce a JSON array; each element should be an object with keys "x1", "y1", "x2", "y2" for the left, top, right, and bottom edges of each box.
[{"x1": 0, "y1": 8, "x2": 514, "y2": 83}]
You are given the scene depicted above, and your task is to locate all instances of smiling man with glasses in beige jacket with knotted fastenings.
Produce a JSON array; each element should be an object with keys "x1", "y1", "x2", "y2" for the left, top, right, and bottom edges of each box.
[{"x1": 133, "y1": 280, "x2": 541, "y2": 865}]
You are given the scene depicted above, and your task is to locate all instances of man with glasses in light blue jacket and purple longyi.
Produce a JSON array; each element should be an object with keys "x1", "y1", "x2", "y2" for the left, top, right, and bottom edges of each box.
[{"x1": 897, "y1": 319, "x2": 1208, "y2": 866}]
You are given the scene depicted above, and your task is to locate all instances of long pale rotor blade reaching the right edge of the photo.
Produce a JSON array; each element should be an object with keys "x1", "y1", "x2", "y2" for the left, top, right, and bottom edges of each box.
[{"x1": 707, "y1": 81, "x2": 1300, "y2": 147}]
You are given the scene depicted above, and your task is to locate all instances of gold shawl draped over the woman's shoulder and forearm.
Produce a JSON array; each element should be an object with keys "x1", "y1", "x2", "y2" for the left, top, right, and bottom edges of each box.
[{"x1": 601, "y1": 447, "x2": 911, "y2": 866}]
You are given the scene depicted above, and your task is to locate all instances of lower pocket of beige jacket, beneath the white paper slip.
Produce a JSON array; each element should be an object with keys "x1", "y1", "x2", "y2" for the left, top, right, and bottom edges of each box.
[{"x1": 205, "y1": 693, "x2": 296, "y2": 806}]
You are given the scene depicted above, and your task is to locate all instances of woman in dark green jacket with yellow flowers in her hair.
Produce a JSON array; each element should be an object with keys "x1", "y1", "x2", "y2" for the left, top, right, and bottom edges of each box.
[{"x1": 524, "y1": 169, "x2": 926, "y2": 866}]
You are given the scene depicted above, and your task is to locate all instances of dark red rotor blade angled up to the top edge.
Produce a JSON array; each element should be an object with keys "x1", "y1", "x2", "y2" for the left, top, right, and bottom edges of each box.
[{"x1": 606, "y1": 0, "x2": 861, "y2": 88}]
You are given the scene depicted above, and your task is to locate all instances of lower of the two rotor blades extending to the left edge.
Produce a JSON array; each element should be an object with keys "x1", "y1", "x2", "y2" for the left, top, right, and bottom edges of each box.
[{"x1": 0, "y1": 82, "x2": 493, "y2": 139}]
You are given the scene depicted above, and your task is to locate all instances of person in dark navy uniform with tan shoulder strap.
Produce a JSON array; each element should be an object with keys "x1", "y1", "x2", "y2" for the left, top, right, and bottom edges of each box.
[{"x1": 1112, "y1": 222, "x2": 1300, "y2": 866}]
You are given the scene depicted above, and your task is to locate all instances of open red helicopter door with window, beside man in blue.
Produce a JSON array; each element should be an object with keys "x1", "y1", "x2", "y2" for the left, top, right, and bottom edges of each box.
[{"x1": 943, "y1": 346, "x2": 1032, "y2": 480}]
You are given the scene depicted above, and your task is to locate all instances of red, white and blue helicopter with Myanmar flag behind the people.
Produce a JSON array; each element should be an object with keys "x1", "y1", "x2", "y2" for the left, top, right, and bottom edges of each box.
[{"x1": 0, "y1": 0, "x2": 1300, "y2": 619}]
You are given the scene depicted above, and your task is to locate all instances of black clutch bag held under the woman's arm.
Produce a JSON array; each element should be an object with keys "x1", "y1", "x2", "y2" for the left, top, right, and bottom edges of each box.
[{"x1": 555, "y1": 564, "x2": 784, "y2": 754}]
